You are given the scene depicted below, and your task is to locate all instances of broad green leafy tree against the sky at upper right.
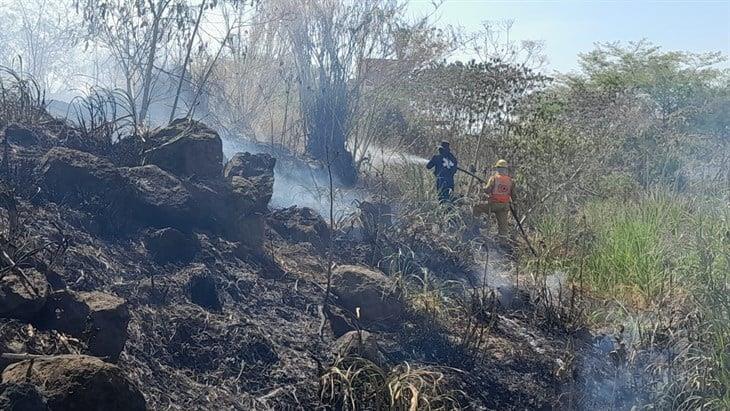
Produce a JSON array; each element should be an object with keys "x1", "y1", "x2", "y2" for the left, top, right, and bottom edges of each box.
[{"x1": 566, "y1": 40, "x2": 728, "y2": 186}]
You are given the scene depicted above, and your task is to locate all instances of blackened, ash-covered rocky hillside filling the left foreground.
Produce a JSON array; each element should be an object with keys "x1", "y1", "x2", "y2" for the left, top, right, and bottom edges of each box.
[{"x1": 0, "y1": 118, "x2": 630, "y2": 410}]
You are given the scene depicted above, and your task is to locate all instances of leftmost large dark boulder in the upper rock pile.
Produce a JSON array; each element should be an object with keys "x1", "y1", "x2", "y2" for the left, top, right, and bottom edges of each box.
[{"x1": 37, "y1": 147, "x2": 122, "y2": 202}]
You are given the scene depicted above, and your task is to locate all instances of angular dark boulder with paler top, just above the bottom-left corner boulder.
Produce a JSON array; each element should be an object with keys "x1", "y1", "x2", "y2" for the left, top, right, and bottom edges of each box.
[{"x1": 34, "y1": 290, "x2": 129, "y2": 362}]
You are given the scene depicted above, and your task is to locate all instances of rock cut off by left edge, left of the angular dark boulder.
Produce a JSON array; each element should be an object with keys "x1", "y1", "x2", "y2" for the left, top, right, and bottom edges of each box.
[{"x1": 0, "y1": 268, "x2": 49, "y2": 319}]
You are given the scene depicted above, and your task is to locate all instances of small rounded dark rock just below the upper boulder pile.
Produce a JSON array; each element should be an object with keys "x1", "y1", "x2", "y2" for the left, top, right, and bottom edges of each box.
[{"x1": 145, "y1": 227, "x2": 200, "y2": 264}]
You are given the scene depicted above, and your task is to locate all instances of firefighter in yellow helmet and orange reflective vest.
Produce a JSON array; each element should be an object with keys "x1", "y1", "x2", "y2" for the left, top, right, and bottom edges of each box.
[{"x1": 474, "y1": 159, "x2": 514, "y2": 241}]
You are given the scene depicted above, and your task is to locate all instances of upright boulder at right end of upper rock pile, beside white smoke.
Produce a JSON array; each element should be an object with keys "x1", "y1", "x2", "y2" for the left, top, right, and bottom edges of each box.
[{"x1": 223, "y1": 153, "x2": 276, "y2": 214}]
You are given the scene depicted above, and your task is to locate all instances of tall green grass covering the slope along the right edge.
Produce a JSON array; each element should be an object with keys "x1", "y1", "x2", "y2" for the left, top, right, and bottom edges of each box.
[{"x1": 536, "y1": 191, "x2": 730, "y2": 409}]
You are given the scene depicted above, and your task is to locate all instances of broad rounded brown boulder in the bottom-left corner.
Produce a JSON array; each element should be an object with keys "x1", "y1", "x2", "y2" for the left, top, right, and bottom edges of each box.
[{"x1": 2, "y1": 355, "x2": 147, "y2": 411}]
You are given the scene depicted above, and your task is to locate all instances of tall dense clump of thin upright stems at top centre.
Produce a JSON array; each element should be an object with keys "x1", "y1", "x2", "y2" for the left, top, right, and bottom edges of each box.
[{"x1": 277, "y1": 0, "x2": 403, "y2": 184}]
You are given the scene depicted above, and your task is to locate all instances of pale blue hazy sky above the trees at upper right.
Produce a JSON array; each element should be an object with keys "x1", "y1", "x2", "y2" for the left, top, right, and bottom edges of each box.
[{"x1": 409, "y1": 0, "x2": 730, "y2": 71}]
